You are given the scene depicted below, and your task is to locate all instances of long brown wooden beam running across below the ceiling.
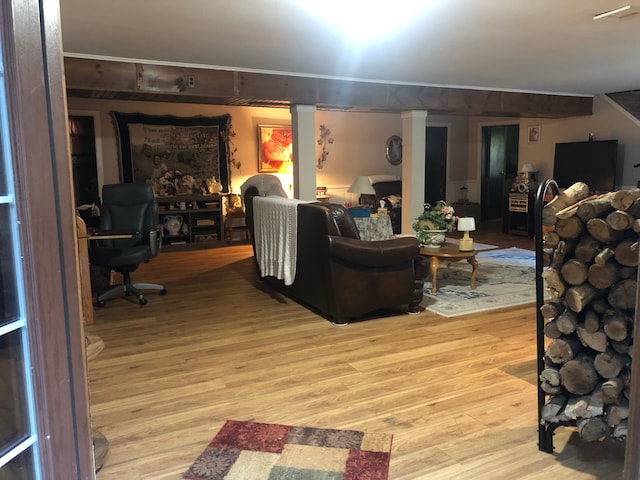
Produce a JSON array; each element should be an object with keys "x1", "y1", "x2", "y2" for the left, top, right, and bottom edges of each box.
[{"x1": 64, "y1": 57, "x2": 593, "y2": 118}]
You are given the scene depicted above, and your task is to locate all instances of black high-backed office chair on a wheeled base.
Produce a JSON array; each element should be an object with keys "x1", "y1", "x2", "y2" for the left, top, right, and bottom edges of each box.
[{"x1": 89, "y1": 183, "x2": 167, "y2": 307}]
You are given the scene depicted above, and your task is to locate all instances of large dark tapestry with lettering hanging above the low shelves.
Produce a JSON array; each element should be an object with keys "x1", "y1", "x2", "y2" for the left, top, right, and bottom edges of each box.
[{"x1": 110, "y1": 112, "x2": 231, "y2": 192}]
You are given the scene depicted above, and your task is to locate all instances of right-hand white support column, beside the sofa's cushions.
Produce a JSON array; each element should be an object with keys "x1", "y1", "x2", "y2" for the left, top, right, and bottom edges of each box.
[{"x1": 401, "y1": 110, "x2": 427, "y2": 234}]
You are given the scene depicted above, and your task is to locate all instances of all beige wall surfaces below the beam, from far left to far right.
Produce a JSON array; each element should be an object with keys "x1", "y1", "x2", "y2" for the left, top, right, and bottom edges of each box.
[{"x1": 68, "y1": 97, "x2": 640, "y2": 209}]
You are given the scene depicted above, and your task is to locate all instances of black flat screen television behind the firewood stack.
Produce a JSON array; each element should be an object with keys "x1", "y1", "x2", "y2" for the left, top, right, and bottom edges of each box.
[{"x1": 553, "y1": 140, "x2": 618, "y2": 193}]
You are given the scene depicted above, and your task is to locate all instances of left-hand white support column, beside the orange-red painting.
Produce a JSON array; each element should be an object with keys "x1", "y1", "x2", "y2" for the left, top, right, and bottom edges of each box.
[{"x1": 290, "y1": 105, "x2": 316, "y2": 201}]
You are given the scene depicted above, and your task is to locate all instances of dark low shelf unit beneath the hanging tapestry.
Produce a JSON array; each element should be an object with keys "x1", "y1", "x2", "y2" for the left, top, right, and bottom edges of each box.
[{"x1": 156, "y1": 195, "x2": 224, "y2": 248}]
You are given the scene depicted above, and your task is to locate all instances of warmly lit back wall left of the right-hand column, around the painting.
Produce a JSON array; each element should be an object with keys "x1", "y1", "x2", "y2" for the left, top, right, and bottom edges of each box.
[{"x1": 68, "y1": 98, "x2": 401, "y2": 203}]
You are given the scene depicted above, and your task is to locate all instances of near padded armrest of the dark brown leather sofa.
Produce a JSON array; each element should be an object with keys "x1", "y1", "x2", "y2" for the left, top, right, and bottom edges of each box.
[{"x1": 326, "y1": 235, "x2": 420, "y2": 267}]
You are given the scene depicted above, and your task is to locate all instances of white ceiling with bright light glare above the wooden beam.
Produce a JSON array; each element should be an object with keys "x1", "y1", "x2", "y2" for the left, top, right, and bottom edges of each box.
[{"x1": 60, "y1": 0, "x2": 640, "y2": 95}]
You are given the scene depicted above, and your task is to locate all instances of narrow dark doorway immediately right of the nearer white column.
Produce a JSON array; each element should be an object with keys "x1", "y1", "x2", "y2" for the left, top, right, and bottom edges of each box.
[{"x1": 424, "y1": 127, "x2": 449, "y2": 205}]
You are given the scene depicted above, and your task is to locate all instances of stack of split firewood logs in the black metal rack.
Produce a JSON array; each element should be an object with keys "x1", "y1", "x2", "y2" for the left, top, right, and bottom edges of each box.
[{"x1": 540, "y1": 183, "x2": 640, "y2": 441}]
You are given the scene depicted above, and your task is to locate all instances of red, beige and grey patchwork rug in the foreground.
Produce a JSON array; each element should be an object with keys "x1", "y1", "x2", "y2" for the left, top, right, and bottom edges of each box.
[{"x1": 182, "y1": 420, "x2": 393, "y2": 480}]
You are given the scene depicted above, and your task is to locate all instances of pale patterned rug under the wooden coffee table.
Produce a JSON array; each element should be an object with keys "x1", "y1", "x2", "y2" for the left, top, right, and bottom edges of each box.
[{"x1": 422, "y1": 247, "x2": 536, "y2": 317}]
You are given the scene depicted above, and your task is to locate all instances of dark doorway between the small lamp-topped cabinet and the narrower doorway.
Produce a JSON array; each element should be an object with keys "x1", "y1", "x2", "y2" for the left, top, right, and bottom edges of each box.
[{"x1": 480, "y1": 125, "x2": 520, "y2": 221}]
